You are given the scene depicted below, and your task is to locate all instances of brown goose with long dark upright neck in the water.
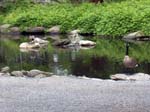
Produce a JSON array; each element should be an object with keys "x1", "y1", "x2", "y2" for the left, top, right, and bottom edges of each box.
[{"x1": 123, "y1": 43, "x2": 138, "y2": 68}]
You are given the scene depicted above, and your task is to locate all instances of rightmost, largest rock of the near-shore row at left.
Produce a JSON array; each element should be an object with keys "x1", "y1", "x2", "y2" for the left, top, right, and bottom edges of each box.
[{"x1": 27, "y1": 69, "x2": 52, "y2": 77}]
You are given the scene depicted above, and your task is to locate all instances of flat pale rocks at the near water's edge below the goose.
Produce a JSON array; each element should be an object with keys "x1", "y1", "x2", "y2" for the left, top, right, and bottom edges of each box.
[{"x1": 110, "y1": 73, "x2": 150, "y2": 81}]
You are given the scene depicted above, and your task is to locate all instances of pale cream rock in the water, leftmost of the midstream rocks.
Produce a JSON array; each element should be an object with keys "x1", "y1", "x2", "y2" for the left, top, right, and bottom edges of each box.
[{"x1": 19, "y1": 42, "x2": 41, "y2": 49}]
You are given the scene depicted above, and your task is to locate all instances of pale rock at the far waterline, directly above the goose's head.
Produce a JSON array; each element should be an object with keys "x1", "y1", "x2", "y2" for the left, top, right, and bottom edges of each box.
[{"x1": 123, "y1": 31, "x2": 150, "y2": 41}]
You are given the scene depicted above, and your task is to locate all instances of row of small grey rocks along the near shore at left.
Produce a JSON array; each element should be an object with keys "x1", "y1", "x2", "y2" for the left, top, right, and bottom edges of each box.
[{"x1": 0, "y1": 67, "x2": 53, "y2": 78}]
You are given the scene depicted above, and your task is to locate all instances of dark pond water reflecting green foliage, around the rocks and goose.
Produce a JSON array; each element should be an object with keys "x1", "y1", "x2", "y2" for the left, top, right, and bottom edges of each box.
[{"x1": 0, "y1": 35, "x2": 150, "y2": 79}]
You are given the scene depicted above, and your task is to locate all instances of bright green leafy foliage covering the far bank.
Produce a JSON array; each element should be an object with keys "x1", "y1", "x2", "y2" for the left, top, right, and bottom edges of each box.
[{"x1": 0, "y1": 0, "x2": 150, "y2": 35}]
